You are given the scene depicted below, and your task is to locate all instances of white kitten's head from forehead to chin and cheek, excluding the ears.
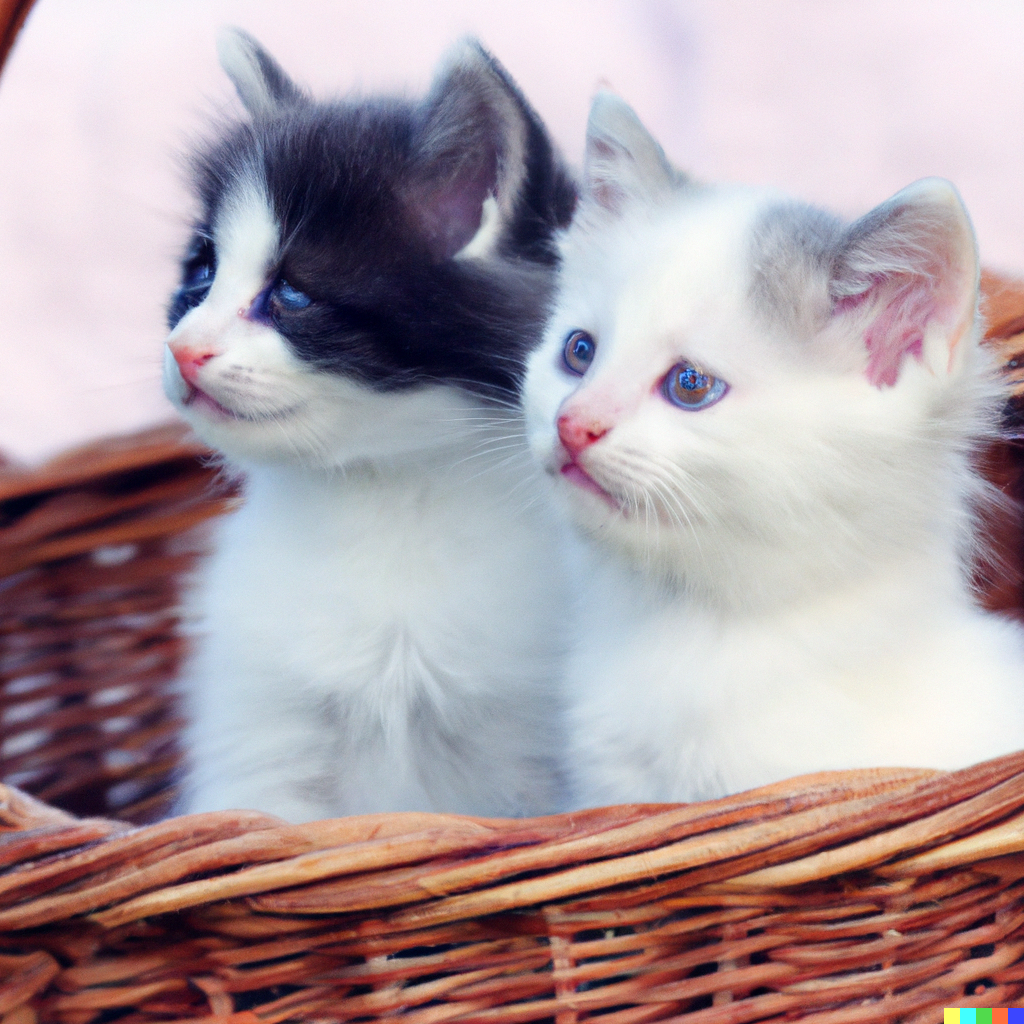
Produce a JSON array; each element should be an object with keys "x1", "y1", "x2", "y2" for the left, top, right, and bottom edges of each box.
[{"x1": 524, "y1": 172, "x2": 983, "y2": 591}]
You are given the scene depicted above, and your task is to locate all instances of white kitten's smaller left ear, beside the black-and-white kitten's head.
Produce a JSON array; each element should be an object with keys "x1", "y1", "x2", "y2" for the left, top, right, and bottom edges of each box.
[{"x1": 584, "y1": 90, "x2": 683, "y2": 213}]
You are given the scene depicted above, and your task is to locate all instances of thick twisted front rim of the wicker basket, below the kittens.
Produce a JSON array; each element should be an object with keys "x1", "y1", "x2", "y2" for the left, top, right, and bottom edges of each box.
[{"x1": 6, "y1": 752, "x2": 1024, "y2": 932}]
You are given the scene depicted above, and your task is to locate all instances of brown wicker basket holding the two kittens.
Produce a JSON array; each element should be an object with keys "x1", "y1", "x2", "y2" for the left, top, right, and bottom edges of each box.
[{"x1": 9, "y1": 6, "x2": 1024, "y2": 1024}]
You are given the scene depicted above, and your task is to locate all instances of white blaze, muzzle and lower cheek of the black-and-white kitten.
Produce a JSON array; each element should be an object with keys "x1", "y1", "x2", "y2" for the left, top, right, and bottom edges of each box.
[{"x1": 164, "y1": 182, "x2": 468, "y2": 465}]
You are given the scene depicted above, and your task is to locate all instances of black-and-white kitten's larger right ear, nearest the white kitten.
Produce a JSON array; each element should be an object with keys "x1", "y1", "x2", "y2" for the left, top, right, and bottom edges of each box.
[{"x1": 406, "y1": 40, "x2": 539, "y2": 260}]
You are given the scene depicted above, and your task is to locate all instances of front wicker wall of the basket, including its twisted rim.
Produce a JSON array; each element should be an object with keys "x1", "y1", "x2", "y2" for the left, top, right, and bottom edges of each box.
[{"x1": 0, "y1": 755, "x2": 1024, "y2": 1024}]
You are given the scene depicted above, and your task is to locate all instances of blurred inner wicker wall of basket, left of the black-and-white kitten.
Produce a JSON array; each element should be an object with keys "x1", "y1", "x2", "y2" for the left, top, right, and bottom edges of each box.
[{"x1": 0, "y1": 426, "x2": 230, "y2": 821}]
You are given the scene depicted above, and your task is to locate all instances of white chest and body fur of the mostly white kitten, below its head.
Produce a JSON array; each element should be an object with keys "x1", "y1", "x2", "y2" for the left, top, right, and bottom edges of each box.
[{"x1": 567, "y1": 559, "x2": 1024, "y2": 806}]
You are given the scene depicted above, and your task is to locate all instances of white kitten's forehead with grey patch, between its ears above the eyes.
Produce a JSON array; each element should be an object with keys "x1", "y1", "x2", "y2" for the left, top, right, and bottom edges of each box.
[{"x1": 566, "y1": 186, "x2": 843, "y2": 372}]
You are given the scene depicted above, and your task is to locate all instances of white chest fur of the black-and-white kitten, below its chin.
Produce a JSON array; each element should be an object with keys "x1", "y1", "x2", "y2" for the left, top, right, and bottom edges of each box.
[{"x1": 179, "y1": 428, "x2": 568, "y2": 820}]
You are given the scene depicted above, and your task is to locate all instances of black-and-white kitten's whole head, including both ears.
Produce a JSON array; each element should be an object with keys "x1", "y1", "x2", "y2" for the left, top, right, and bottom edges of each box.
[{"x1": 164, "y1": 31, "x2": 574, "y2": 466}]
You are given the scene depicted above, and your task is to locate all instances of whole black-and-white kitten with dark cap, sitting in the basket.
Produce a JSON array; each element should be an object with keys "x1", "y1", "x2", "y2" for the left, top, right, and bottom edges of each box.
[{"x1": 165, "y1": 31, "x2": 575, "y2": 821}]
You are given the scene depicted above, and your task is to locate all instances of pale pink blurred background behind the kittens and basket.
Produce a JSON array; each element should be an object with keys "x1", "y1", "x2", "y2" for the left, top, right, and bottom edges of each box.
[{"x1": 0, "y1": 0, "x2": 1024, "y2": 462}]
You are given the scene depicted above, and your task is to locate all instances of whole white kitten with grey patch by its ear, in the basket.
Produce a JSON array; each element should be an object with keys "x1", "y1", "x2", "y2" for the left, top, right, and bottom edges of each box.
[{"x1": 524, "y1": 94, "x2": 1024, "y2": 806}]
